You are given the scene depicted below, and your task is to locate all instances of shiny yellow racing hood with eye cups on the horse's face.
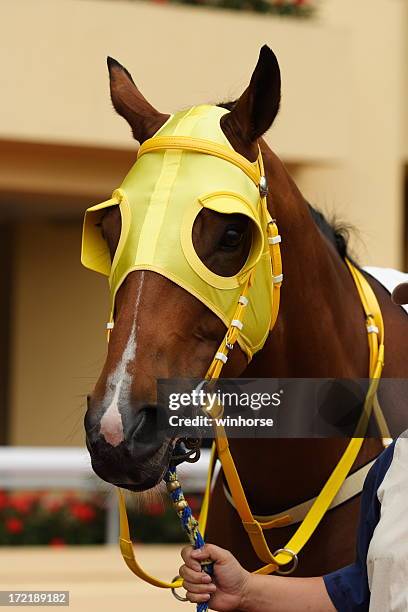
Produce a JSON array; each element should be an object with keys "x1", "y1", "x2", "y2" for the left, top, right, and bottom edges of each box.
[{"x1": 82, "y1": 105, "x2": 273, "y2": 359}]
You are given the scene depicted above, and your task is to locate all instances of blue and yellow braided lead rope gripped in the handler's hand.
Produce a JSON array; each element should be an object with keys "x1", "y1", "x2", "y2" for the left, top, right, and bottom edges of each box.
[{"x1": 164, "y1": 452, "x2": 214, "y2": 612}]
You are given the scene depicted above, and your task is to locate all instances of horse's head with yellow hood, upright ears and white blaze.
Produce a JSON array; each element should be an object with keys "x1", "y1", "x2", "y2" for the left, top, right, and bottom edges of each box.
[{"x1": 82, "y1": 47, "x2": 280, "y2": 490}]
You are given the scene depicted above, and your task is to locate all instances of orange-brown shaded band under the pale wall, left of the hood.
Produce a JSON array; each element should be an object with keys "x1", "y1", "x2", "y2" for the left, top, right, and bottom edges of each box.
[{"x1": 0, "y1": 140, "x2": 137, "y2": 218}]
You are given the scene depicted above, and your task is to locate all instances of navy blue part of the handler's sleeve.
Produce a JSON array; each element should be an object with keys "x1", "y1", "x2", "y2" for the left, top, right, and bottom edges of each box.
[{"x1": 323, "y1": 442, "x2": 395, "y2": 612}]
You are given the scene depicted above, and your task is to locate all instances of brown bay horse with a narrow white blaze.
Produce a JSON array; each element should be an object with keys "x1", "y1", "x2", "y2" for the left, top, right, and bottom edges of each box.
[{"x1": 85, "y1": 46, "x2": 408, "y2": 576}]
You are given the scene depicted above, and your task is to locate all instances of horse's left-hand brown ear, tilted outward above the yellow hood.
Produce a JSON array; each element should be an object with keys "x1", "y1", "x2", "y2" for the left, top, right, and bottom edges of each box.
[{"x1": 107, "y1": 57, "x2": 169, "y2": 143}]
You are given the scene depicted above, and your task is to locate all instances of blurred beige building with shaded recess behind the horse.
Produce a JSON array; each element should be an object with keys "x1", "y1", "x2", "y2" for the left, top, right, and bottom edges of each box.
[{"x1": 0, "y1": 0, "x2": 408, "y2": 446}]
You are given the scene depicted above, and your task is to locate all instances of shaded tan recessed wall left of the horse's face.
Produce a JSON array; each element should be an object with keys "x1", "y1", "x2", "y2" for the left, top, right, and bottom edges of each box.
[{"x1": 11, "y1": 220, "x2": 108, "y2": 446}]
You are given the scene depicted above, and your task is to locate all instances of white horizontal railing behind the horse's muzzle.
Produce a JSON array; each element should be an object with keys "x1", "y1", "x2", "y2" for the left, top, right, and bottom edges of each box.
[{"x1": 0, "y1": 446, "x2": 209, "y2": 544}]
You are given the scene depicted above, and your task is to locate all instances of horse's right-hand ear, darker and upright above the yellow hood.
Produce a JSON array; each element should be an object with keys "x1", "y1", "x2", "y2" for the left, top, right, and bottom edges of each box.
[{"x1": 222, "y1": 45, "x2": 281, "y2": 145}]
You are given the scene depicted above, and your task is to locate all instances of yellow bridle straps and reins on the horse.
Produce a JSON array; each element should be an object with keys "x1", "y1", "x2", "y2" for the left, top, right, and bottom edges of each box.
[{"x1": 118, "y1": 138, "x2": 390, "y2": 589}]
